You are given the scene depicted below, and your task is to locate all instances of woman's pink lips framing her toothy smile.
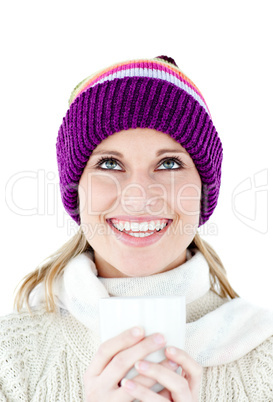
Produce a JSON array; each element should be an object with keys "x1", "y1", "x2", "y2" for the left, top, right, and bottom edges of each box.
[{"x1": 106, "y1": 216, "x2": 172, "y2": 247}]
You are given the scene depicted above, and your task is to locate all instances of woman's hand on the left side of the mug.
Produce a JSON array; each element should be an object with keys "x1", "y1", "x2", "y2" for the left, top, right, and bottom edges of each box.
[{"x1": 84, "y1": 328, "x2": 178, "y2": 402}]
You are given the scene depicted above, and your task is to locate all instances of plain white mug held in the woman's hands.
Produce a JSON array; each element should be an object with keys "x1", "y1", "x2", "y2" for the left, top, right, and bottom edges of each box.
[{"x1": 99, "y1": 296, "x2": 186, "y2": 392}]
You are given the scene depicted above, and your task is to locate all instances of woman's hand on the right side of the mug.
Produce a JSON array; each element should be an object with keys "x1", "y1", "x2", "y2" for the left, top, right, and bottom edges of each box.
[{"x1": 121, "y1": 347, "x2": 202, "y2": 402}]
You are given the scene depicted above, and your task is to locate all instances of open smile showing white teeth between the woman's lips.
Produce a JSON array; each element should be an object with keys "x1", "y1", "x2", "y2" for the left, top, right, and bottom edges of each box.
[{"x1": 107, "y1": 218, "x2": 172, "y2": 237}]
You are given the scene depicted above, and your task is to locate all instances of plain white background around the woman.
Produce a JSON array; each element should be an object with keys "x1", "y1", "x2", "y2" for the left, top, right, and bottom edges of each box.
[{"x1": 0, "y1": 0, "x2": 273, "y2": 315}]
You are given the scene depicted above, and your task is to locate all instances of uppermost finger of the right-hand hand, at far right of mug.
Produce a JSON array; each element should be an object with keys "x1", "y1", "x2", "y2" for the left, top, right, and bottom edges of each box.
[{"x1": 165, "y1": 347, "x2": 203, "y2": 396}]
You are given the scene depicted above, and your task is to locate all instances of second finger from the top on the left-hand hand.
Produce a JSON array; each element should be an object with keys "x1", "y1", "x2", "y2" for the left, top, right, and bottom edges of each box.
[{"x1": 102, "y1": 334, "x2": 166, "y2": 385}]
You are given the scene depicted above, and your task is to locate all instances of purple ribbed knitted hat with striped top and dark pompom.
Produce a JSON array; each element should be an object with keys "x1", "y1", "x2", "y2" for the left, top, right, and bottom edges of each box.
[{"x1": 56, "y1": 56, "x2": 223, "y2": 226}]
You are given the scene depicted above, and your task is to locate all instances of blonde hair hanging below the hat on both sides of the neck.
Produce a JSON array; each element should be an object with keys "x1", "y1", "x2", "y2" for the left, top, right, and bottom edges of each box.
[{"x1": 14, "y1": 227, "x2": 239, "y2": 313}]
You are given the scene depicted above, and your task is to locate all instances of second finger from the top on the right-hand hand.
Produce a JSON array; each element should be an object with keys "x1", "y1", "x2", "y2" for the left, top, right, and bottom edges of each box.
[{"x1": 135, "y1": 360, "x2": 192, "y2": 402}]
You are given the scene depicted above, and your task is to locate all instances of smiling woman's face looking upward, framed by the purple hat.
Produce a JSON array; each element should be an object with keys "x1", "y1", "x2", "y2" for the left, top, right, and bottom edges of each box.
[{"x1": 78, "y1": 128, "x2": 202, "y2": 277}]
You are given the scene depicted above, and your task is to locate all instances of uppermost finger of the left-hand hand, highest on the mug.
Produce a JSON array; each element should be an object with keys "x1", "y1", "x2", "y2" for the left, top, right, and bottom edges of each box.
[{"x1": 85, "y1": 327, "x2": 144, "y2": 377}]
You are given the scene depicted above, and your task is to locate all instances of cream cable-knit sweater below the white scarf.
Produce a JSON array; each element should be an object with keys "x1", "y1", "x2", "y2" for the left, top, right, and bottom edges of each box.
[{"x1": 0, "y1": 291, "x2": 273, "y2": 402}]
